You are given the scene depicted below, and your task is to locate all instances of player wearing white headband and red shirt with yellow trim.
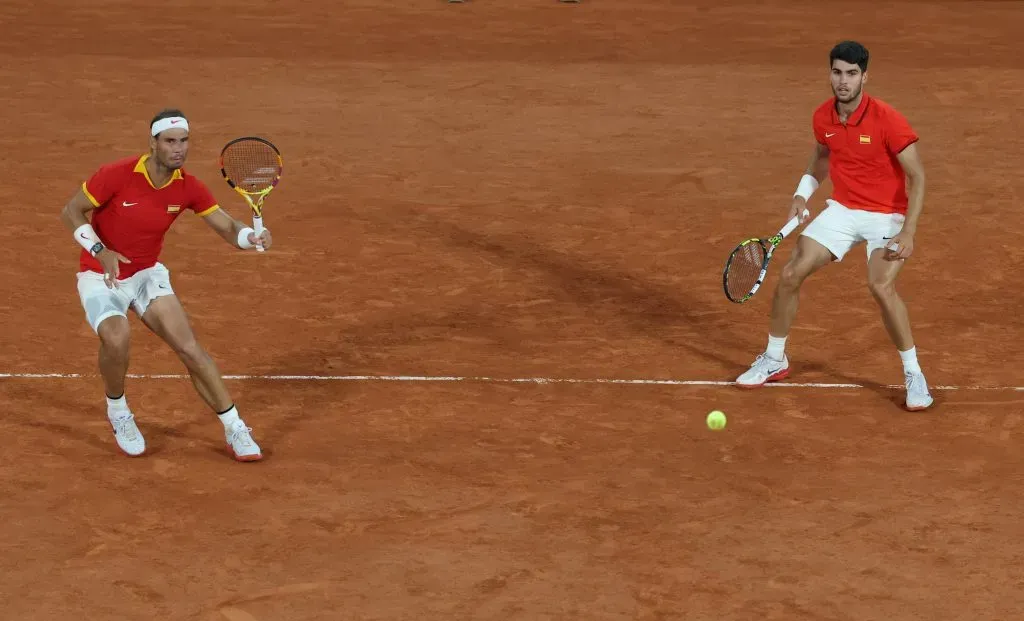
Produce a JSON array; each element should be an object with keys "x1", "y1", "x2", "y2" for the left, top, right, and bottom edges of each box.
[{"x1": 61, "y1": 110, "x2": 271, "y2": 461}]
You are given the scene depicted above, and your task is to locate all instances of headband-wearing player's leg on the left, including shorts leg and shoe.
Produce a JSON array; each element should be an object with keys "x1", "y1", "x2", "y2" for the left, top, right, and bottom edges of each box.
[{"x1": 78, "y1": 272, "x2": 145, "y2": 457}]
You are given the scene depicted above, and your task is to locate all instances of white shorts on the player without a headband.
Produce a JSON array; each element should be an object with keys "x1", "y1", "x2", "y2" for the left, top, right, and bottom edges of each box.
[{"x1": 801, "y1": 199, "x2": 906, "y2": 261}]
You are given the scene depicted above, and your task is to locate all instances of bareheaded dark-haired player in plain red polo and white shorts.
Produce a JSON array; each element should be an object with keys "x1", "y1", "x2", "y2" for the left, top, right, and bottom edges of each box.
[{"x1": 736, "y1": 41, "x2": 933, "y2": 410}]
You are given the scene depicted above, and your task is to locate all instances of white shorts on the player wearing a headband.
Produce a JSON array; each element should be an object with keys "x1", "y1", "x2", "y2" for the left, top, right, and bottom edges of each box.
[{"x1": 78, "y1": 263, "x2": 174, "y2": 332}]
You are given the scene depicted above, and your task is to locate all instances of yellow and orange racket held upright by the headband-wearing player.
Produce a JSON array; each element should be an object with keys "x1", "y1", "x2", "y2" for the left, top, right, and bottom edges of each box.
[{"x1": 219, "y1": 136, "x2": 285, "y2": 252}]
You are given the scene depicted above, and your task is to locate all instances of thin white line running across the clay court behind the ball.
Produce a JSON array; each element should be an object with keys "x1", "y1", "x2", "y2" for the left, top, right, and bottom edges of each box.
[{"x1": 0, "y1": 373, "x2": 1024, "y2": 391}]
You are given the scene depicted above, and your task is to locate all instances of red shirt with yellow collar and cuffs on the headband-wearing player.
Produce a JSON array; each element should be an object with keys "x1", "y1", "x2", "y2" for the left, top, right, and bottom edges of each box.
[{"x1": 79, "y1": 154, "x2": 220, "y2": 279}]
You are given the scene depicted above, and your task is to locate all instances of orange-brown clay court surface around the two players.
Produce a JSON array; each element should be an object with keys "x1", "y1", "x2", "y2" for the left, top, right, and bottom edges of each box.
[{"x1": 0, "y1": 0, "x2": 1024, "y2": 621}]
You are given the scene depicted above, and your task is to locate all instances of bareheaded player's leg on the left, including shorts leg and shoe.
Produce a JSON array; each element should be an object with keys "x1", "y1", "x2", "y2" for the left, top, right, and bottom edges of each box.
[{"x1": 736, "y1": 203, "x2": 859, "y2": 388}]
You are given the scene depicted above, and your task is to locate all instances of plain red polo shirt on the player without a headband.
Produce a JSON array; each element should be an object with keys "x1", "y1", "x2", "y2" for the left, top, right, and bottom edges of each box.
[{"x1": 811, "y1": 93, "x2": 918, "y2": 213}]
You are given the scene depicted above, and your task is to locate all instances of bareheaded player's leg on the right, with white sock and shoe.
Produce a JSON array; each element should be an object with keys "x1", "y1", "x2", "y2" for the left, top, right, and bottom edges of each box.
[{"x1": 866, "y1": 222, "x2": 933, "y2": 410}]
